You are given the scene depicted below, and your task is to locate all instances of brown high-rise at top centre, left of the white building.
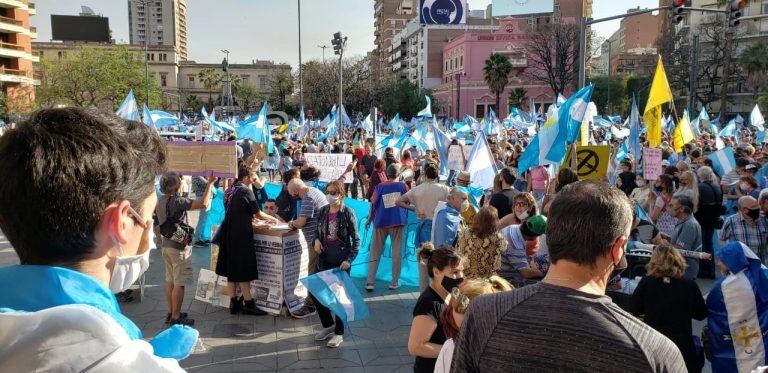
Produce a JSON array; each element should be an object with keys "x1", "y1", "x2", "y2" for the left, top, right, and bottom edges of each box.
[{"x1": 371, "y1": 0, "x2": 419, "y2": 80}]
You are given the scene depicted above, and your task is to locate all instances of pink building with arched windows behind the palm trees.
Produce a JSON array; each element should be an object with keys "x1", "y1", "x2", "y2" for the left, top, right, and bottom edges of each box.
[{"x1": 433, "y1": 18, "x2": 574, "y2": 118}]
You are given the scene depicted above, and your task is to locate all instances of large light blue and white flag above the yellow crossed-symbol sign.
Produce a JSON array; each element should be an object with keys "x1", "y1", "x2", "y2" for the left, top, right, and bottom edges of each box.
[{"x1": 547, "y1": 84, "x2": 594, "y2": 163}]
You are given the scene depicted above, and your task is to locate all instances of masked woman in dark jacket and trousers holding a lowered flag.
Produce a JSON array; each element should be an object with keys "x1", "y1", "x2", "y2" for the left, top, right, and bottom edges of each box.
[{"x1": 310, "y1": 180, "x2": 360, "y2": 348}]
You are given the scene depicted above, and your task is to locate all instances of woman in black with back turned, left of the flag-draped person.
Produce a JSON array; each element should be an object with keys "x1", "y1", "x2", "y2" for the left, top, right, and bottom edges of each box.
[{"x1": 631, "y1": 244, "x2": 707, "y2": 372}]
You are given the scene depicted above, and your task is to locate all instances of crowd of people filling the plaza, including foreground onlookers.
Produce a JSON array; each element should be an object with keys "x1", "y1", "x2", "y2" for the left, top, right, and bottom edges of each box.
[{"x1": 0, "y1": 105, "x2": 768, "y2": 372}]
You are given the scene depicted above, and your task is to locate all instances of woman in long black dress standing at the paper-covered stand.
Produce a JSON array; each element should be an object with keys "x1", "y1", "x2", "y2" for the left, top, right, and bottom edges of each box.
[{"x1": 216, "y1": 165, "x2": 278, "y2": 315}]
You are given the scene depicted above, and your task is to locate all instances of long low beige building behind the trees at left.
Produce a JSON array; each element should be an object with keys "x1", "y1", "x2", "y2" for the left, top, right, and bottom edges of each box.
[{"x1": 33, "y1": 42, "x2": 291, "y2": 111}]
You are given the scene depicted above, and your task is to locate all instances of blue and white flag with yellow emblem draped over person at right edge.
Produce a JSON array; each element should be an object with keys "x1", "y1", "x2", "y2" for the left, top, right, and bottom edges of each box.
[{"x1": 707, "y1": 242, "x2": 768, "y2": 373}]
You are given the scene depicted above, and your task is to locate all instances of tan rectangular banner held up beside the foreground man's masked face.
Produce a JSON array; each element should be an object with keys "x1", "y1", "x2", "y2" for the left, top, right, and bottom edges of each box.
[{"x1": 166, "y1": 141, "x2": 237, "y2": 178}]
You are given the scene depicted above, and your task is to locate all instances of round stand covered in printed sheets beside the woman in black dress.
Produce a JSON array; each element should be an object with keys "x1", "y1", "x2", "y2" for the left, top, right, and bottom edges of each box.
[{"x1": 251, "y1": 229, "x2": 309, "y2": 315}]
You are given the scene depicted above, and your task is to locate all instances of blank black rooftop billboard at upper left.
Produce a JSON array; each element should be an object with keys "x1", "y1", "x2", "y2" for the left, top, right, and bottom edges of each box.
[{"x1": 51, "y1": 14, "x2": 110, "y2": 42}]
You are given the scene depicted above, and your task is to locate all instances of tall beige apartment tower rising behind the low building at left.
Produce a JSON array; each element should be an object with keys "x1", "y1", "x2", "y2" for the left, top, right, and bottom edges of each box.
[{"x1": 128, "y1": 0, "x2": 188, "y2": 60}]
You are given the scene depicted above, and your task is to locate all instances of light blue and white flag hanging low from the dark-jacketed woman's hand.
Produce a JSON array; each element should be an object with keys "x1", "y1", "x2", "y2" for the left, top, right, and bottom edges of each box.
[{"x1": 299, "y1": 268, "x2": 368, "y2": 324}]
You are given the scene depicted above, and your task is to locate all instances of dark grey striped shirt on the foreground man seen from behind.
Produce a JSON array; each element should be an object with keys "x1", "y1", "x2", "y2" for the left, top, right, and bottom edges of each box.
[{"x1": 451, "y1": 283, "x2": 686, "y2": 373}]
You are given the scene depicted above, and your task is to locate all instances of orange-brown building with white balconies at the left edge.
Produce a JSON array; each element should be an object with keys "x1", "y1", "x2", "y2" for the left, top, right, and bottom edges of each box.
[{"x1": 0, "y1": 0, "x2": 40, "y2": 115}]
